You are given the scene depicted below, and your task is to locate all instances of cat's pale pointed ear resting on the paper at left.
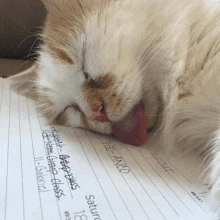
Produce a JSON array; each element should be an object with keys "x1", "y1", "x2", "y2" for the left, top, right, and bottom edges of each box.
[{"x1": 9, "y1": 63, "x2": 38, "y2": 98}]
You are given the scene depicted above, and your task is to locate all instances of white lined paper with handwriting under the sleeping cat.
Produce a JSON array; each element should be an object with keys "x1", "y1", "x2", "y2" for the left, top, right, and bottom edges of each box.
[{"x1": 0, "y1": 78, "x2": 219, "y2": 220}]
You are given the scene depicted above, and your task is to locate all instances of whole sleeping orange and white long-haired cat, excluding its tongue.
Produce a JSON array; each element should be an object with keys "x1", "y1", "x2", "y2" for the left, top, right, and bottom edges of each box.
[{"x1": 11, "y1": 0, "x2": 220, "y2": 210}]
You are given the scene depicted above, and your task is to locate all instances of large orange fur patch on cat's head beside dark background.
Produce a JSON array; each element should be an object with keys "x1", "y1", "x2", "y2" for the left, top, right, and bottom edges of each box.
[{"x1": 42, "y1": 0, "x2": 85, "y2": 64}]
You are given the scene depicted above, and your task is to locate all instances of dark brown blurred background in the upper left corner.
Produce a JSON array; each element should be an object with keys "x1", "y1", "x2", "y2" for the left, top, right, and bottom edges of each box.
[{"x1": 0, "y1": 0, "x2": 46, "y2": 76}]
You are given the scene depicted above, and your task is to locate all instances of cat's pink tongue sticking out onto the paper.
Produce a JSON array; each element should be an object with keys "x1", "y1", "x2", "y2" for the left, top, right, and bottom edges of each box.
[{"x1": 112, "y1": 102, "x2": 148, "y2": 146}]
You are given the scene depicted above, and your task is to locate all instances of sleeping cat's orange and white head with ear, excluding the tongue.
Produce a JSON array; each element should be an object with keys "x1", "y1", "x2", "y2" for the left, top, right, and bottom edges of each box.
[{"x1": 13, "y1": 0, "x2": 168, "y2": 133}]
